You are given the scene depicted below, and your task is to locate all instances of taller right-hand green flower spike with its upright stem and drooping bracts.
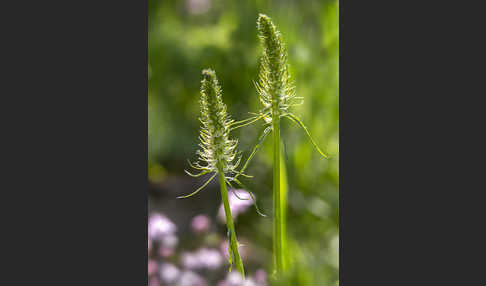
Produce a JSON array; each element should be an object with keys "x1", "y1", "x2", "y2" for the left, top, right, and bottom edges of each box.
[{"x1": 235, "y1": 14, "x2": 327, "y2": 276}]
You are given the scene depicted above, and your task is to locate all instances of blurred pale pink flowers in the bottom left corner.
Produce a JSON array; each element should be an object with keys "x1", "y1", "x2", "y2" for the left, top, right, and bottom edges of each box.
[{"x1": 147, "y1": 210, "x2": 267, "y2": 286}]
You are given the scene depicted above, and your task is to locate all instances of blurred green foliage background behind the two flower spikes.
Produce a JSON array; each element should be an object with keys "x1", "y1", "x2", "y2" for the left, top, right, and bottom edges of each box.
[{"x1": 148, "y1": 0, "x2": 339, "y2": 285}]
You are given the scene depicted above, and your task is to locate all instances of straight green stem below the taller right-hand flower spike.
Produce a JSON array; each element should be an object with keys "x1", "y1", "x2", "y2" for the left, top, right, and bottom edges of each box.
[{"x1": 272, "y1": 115, "x2": 284, "y2": 276}]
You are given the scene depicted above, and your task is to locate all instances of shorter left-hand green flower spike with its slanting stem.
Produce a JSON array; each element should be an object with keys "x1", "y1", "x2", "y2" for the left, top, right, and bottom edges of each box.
[{"x1": 178, "y1": 69, "x2": 264, "y2": 276}]
